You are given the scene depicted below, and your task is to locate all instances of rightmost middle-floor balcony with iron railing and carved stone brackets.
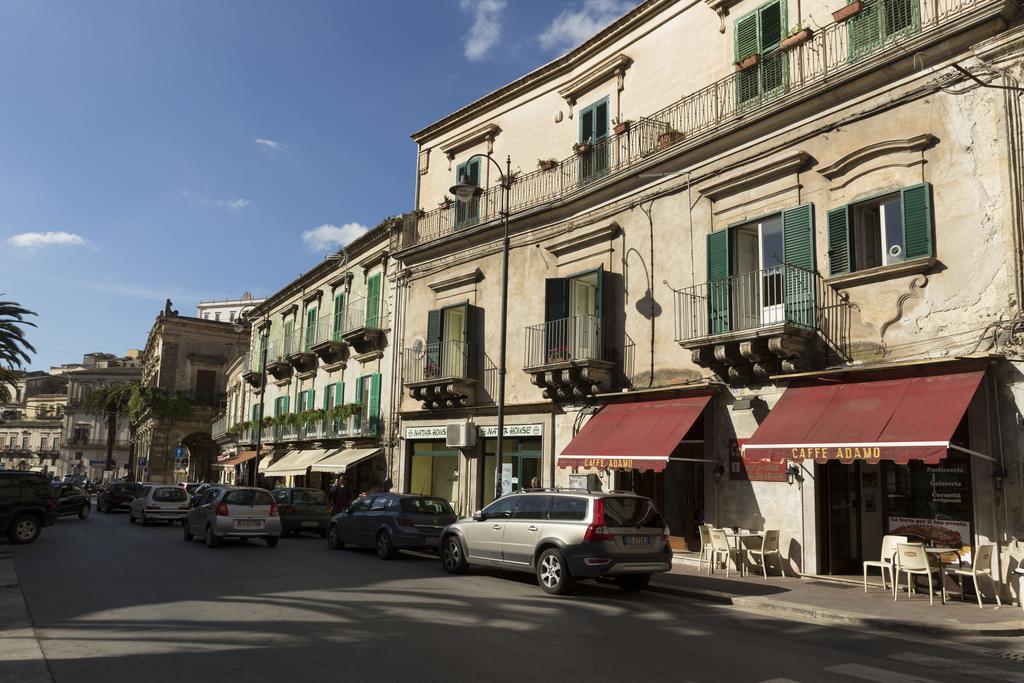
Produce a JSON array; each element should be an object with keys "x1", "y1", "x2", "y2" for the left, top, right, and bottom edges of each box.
[{"x1": 675, "y1": 264, "x2": 850, "y2": 383}]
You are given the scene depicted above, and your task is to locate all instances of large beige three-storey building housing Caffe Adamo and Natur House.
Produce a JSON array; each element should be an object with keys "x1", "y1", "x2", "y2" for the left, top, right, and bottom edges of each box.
[{"x1": 390, "y1": 0, "x2": 1024, "y2": 595}]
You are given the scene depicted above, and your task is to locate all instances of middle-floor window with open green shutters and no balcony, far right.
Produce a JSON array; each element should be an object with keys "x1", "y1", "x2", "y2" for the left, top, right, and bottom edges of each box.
[{"x1": 828, "y1": 183, "x2": 933, "y2": 275}]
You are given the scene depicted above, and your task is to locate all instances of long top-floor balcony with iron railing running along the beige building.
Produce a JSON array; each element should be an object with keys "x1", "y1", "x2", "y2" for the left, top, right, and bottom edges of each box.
[{"x1": 400, "y1": 0, "x2": 999, "y2": 249}]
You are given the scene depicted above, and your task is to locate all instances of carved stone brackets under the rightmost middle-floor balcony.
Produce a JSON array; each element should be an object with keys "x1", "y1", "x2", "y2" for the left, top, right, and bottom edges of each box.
[{"x1": 690, "y1": 328, "x2": 824, "y2": 384}]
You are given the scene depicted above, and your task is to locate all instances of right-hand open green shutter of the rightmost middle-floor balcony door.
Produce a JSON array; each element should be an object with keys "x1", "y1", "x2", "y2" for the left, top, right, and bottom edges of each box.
[{"x1": 782, "y1": 204, "x2": 817, "y2": 328}]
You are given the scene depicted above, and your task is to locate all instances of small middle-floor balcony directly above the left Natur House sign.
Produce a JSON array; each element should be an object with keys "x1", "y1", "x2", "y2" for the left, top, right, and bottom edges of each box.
[{"x1": 402, "y1": 341, "x2": 477, "y2": 409}]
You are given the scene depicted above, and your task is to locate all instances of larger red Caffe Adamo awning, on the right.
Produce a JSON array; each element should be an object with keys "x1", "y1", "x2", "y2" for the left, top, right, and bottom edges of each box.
[{"x1": 743, "y1": 370, "x2": 985, "y2": 464}]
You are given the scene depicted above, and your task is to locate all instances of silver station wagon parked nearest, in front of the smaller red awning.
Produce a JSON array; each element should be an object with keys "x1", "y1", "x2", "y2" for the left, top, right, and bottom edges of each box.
[{"x1": 440, "y1": 489, "x2": 672, "y2": 595}]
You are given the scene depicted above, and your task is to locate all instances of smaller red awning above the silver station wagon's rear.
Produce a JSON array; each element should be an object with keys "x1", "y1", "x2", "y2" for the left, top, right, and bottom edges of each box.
[{"x1": 558, "y1": 394, "x2": 711, "y2": 472}]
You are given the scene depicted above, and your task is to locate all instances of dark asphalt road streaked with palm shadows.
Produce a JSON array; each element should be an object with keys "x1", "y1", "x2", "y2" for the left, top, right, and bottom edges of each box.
[{"x1": 0, "y1": 513, "x2": 1024, "y2": 683}]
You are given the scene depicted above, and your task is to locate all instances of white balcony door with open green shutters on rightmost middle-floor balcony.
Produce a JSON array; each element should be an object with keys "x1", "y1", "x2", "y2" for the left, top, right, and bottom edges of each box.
[{"x1": 708, "y1": 204, "x2": 815, "y2": 334}]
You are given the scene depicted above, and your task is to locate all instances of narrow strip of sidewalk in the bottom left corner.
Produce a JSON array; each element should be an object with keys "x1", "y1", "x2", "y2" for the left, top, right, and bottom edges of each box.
[{"x1": 0, "y1": 546, "x2": 53, "y2": 683}]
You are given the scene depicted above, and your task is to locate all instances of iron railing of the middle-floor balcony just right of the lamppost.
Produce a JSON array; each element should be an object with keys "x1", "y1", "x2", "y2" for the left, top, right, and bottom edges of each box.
[{"x1": 526, "y1": 315, "x2": 612, "y2": 368}]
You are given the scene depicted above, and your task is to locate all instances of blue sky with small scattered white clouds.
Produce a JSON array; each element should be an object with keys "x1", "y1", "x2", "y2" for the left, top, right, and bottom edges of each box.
[{"x1": 0, "y1": 0, "x2": 635, "y2": 370}]
